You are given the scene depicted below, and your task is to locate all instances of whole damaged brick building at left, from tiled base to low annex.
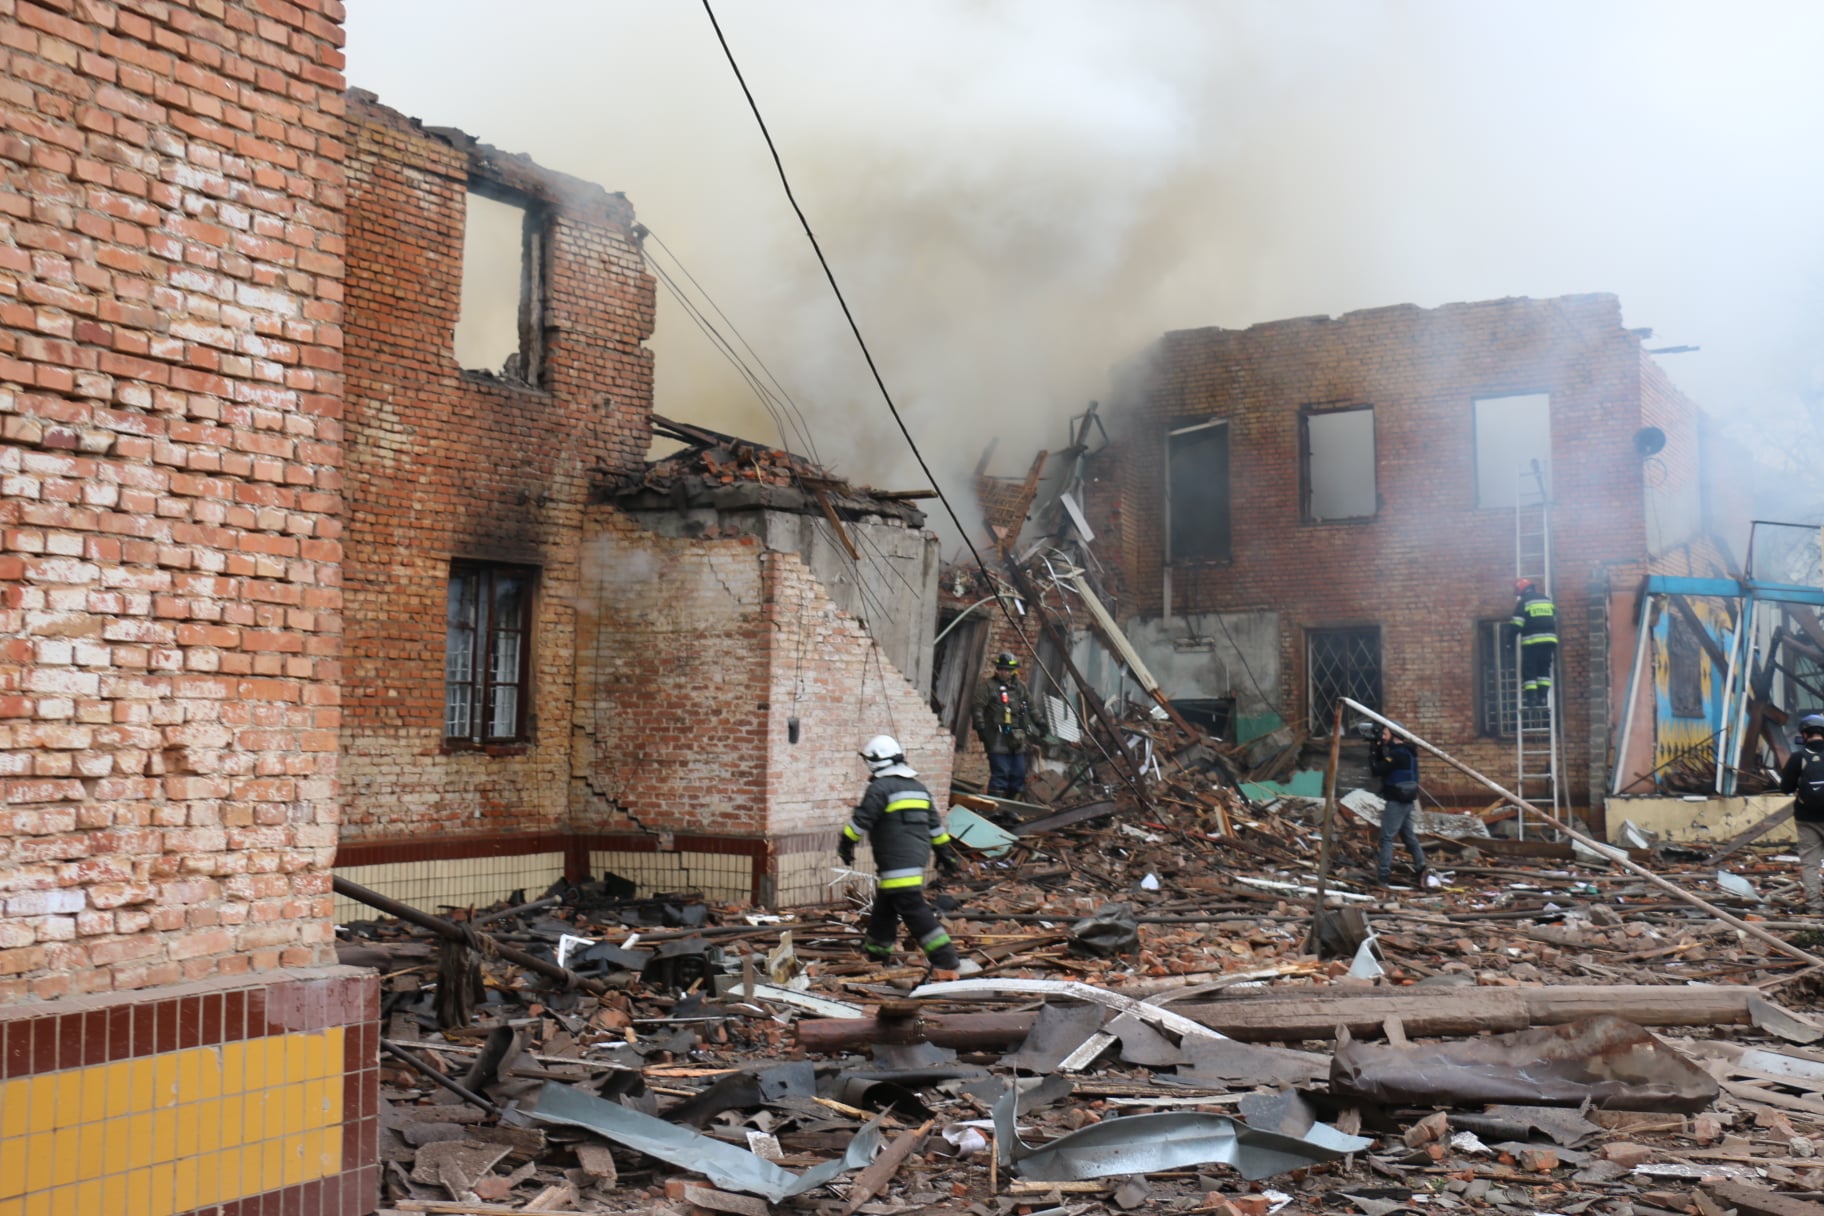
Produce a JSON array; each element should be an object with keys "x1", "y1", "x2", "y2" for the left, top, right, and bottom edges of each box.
[{"x1": 0, "y1": 0, "x2": 950, "y2": 1214}]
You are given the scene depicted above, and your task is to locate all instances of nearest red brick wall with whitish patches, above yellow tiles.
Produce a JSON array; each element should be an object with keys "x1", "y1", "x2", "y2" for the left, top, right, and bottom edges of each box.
[{"x1": 0, "y1": 0, "x2": 343, "y2": 1003}]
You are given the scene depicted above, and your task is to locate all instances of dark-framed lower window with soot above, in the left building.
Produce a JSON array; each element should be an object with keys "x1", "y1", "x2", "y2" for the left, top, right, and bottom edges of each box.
[{"x1": 443, "y1": 562, "x2": 536, "y2": 746}]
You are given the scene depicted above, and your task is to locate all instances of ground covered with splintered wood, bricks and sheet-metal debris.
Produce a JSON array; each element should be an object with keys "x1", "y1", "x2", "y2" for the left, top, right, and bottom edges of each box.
[{"x1": 343, "y1": 769, "x2": 1824, "y2": 1216}]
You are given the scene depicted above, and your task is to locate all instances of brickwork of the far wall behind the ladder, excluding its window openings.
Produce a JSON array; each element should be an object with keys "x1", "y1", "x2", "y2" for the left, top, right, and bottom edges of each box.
[{"x1": 1114, "y1": 295, "x2": 1689, "y2": 799}]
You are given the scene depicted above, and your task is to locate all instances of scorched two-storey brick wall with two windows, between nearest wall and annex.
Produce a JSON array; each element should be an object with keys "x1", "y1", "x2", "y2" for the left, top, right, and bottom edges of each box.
[{"x1": 341, "y1": 93, "x2": 653, "y2": 840}]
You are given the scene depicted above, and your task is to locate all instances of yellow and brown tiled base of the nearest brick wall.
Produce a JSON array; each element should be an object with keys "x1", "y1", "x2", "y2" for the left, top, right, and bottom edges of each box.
[{"x1": 0, "y1": 966, "x2": 379, "y2": 1216}]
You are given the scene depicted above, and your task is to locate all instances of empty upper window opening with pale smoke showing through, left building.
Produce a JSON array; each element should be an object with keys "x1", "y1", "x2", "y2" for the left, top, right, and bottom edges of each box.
[{"x1": 454, "y1": 190, "x2": 545, "y2": 386}]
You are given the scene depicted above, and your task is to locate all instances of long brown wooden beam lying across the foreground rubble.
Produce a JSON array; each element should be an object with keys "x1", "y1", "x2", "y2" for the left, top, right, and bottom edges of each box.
[{"x1": 797, "y1": 984, "x2": 1809, "y2": 1052}]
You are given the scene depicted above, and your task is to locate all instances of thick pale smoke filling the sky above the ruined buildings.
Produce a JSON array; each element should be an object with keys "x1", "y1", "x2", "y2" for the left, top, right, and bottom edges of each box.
[{"x1": 348, "y1": 0, "x2": 1824, "y2": 528}]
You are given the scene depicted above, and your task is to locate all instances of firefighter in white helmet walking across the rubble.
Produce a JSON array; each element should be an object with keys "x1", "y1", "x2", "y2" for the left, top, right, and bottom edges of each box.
[{"x1": 835, "y1": 735, "x2": 959, "y2": 979}]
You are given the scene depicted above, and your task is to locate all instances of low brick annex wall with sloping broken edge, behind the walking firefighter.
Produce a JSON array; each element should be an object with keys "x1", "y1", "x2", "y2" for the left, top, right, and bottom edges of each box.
[{"x1": 576, "y1": 525, "x2": 950, "y2": 848}]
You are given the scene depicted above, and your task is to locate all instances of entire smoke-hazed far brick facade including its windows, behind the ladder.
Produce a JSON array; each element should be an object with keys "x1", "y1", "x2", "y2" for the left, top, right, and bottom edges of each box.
[{"x1": 1105, "y1": 295, "x2": 1746, "y2": 816}]
